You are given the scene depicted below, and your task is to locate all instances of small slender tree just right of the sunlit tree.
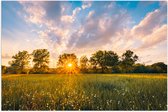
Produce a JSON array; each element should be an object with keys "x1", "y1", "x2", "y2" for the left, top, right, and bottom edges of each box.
[{"x1": 80, "y1": 56, "x2": 88, "y2": 72}]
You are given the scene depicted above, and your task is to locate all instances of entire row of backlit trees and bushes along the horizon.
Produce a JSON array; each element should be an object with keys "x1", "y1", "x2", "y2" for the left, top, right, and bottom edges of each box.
[{"x1": 2, "y1": 49, "x2": 167, "y2": 74}]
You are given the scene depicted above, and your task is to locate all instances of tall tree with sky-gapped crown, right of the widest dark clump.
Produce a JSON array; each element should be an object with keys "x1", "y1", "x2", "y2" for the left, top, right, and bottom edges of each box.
[{"x1": 121, "y1": 50, "x2": 138, "y2": 72}]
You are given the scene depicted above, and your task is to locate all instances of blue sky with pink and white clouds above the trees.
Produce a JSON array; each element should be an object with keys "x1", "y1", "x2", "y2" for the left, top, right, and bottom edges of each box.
[{"x1": 1, "y1": 1, "x2": 167, "y2": 67}]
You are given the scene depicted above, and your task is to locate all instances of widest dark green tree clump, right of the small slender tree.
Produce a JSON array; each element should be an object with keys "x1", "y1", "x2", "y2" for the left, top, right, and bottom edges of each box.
[{"x1": 90, "y1": 50, "x2": 118, "y2": 73}]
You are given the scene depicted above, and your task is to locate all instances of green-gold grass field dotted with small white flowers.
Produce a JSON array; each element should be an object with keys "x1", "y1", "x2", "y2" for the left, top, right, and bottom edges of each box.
[{"x1": 2, "y1": 74, "x2": 167, "y2": 110}]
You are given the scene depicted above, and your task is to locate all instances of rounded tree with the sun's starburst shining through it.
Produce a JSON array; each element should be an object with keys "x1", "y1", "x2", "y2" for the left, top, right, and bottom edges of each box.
[{"x1": 57, "y1": 53, "x2": 78, "y2": 73}]
